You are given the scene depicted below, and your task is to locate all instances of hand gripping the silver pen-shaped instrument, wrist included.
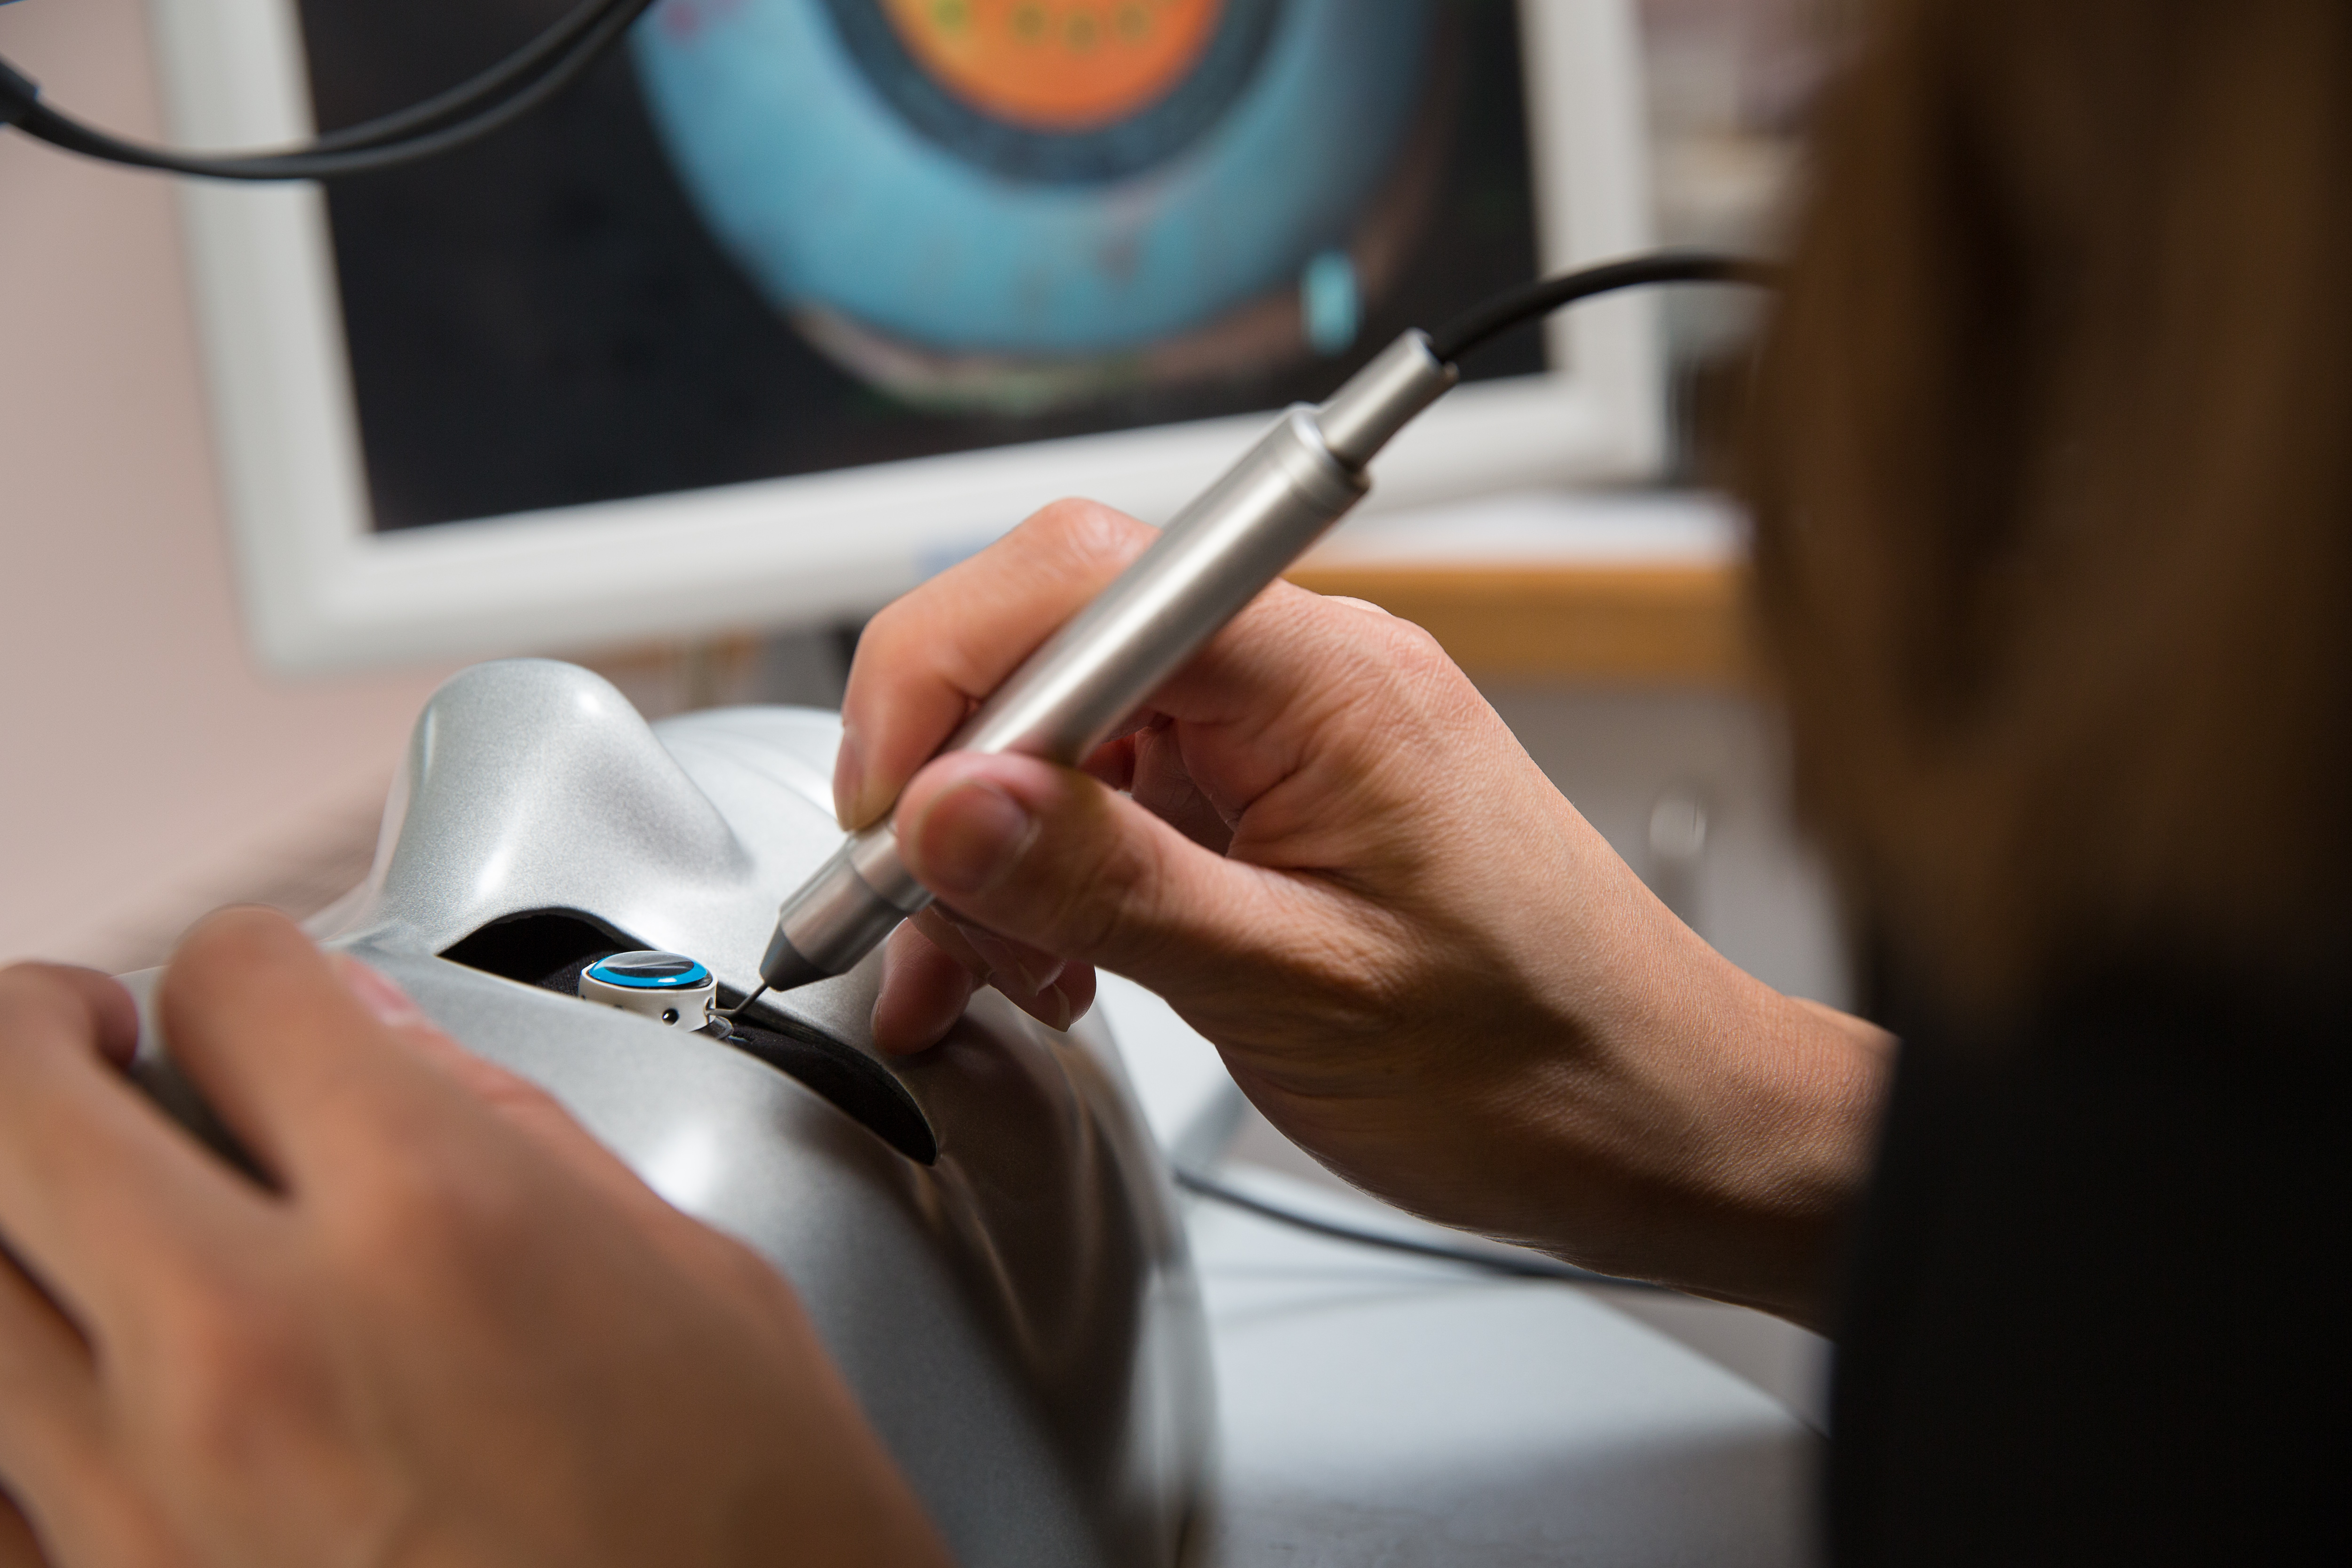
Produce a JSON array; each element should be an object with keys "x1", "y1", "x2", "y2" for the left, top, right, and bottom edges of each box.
[{"x1": 856, "y1": 503, "x2": 1884, "y2": 1319}]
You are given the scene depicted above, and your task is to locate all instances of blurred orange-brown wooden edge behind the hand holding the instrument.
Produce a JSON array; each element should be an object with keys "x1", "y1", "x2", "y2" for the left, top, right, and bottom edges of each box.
[{"x1": 1289, "y1": 562, "x2": 1750, "y2": 686}]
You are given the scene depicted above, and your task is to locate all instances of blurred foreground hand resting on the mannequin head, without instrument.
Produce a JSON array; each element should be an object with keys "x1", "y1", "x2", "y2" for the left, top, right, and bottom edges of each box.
[{"x1": 0, "y1": 910, "x2": 946, "y2": 1568}]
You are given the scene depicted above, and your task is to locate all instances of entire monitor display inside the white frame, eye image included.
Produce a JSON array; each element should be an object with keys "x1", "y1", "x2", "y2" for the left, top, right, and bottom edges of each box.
[{"x1": 301, "y1": 0, "x2": 1550, "y2": 531}]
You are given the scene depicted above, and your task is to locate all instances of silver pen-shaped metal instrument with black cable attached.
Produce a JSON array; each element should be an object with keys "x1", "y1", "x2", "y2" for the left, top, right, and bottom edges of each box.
[{"x1": 736, "y1": 254, "x2": 1769, "y2": 1011}]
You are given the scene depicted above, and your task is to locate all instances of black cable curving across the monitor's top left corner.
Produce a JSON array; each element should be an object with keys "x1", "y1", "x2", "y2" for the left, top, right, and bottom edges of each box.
[{"x1": 0, "y1": 0, "x2": 654, "y2": 181}]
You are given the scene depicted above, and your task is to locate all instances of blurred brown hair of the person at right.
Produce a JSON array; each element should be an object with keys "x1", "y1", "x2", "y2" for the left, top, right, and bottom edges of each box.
[{"x1": 1740, "y1": 0, "x2": 2352, "y2": 1006}]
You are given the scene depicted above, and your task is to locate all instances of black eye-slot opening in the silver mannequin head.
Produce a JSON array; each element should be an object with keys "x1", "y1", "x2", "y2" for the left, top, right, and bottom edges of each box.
[{"x1": 440, "y1": 910, "x2": 938, "y2": 1166}]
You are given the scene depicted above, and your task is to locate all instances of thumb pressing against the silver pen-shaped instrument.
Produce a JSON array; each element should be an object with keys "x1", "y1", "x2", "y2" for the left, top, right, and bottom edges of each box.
[{"x1": 896, "y1": 752, "x2": 1279, "y2": 987}]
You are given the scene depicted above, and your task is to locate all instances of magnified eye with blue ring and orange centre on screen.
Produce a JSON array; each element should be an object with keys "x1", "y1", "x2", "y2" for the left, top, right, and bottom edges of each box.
[{"x1": 637, "y1": 0, "x2": 1435, "y2": 381}]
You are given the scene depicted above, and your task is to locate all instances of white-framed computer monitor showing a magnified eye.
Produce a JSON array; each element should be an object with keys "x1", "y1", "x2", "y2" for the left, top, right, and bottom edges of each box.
[{"x1": 155, "y1": 0, "x2": 1661, "y2": 670}]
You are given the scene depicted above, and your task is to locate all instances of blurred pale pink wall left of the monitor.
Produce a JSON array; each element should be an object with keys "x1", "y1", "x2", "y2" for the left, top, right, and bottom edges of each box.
[{"x1": 0, "y1": 0, "x2": 456, "y2": 966}]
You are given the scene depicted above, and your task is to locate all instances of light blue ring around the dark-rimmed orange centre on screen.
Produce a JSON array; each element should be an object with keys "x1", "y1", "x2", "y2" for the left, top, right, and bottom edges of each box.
[{"x1": 633, "y1": 0, "x2": 1435, "y2": 358}]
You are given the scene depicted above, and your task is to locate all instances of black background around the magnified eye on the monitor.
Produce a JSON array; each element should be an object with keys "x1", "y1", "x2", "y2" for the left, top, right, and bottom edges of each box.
[{"x1": 301, "y1": 0, "x2": 1545, "y2": 529}]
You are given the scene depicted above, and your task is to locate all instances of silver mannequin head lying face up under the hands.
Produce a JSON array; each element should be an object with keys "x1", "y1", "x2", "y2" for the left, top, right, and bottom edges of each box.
[{"x1": 114, "y1": 661, "x2": 1214, "y2": 1568}]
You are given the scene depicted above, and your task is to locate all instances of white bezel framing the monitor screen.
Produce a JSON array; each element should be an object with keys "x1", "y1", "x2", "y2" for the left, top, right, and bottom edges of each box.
[{"x1": 153, "y1": 0, "x2": 1663, "y2": 672}]
